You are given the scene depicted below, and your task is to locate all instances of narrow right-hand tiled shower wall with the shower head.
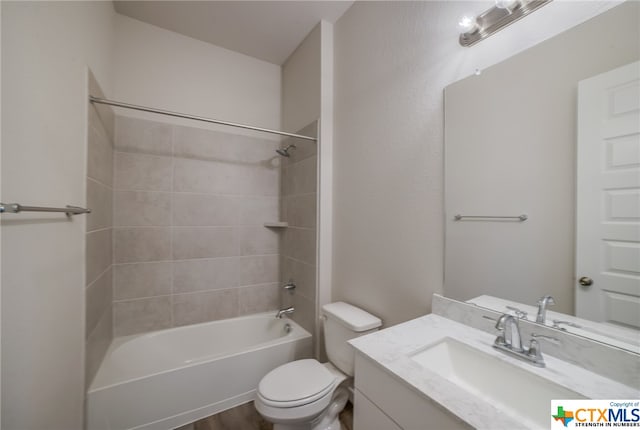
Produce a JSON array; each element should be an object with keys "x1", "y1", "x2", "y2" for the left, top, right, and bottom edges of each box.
[{"x1": 280, "y1": 121, "x2": 318, "y2": 333}]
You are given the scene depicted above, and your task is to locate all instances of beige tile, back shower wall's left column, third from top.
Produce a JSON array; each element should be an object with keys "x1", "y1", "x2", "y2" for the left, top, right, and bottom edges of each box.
[{"x1": 113, "y1": 191, "x2": 171, "y2": 227}]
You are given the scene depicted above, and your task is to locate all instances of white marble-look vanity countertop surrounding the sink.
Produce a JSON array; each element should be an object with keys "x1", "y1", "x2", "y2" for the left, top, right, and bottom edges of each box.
[{"x1": 349, "y1": 314, "x2": 640, "y2": 429}]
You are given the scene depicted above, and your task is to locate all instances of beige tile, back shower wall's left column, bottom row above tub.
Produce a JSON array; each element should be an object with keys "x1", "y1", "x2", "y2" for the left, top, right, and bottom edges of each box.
[{"x1": 113, "y1": 296, "x2": 172, "y2": 336}]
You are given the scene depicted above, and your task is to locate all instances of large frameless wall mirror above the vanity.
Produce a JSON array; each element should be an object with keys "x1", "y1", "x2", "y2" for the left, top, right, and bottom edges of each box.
[{"x1": 444, "y1": 1, "x2": 640, "y2": 352}]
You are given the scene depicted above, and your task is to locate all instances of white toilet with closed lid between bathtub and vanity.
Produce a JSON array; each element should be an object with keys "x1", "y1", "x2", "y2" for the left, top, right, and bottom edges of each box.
[{"x1": 255, "y1": 302, "x2": 382, "y2": 430}]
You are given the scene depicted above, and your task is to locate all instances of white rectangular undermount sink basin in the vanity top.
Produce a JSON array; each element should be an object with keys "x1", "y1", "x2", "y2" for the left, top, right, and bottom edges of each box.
[{"x1": 410, "y1": 338, "x2": 585, "y2": 428}]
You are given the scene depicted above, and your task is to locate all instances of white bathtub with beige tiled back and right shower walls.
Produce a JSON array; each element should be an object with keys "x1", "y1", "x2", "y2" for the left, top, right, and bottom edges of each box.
[{"x1": 86, "y1": 97, "x2": 317, "y2": 430}]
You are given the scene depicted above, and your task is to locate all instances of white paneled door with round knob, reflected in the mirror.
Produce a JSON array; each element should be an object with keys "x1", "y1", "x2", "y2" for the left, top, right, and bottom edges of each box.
[{"x1": 576, "y1": 62, "x2": 640, "y2": 328}]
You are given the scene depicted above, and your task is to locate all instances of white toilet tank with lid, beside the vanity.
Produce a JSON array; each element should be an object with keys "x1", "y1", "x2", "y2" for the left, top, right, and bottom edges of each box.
[{"x1": 322, "y1": 302, "x2": 382, "y2": 376}]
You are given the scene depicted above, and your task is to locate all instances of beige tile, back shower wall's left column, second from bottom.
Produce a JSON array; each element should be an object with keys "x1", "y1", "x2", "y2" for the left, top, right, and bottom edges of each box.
[{"x1": 113, "y1": 262, "x2": 171, "y2": 300}]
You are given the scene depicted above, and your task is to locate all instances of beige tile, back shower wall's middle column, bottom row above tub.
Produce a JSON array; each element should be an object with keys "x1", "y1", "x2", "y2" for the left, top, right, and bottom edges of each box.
[{"x1": 173, "y1": 288, "x2": 238, "y2": 326}]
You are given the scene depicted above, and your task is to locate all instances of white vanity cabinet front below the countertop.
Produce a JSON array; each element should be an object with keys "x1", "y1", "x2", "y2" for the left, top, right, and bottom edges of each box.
[{"x1": 354, "y1": 353, "x2": 472, "y2": 430}]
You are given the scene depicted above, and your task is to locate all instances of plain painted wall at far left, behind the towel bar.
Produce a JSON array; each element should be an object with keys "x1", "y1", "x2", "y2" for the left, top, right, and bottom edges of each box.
[{"x1": 0, "y1": 2, "x2": 115, "y2": 430}]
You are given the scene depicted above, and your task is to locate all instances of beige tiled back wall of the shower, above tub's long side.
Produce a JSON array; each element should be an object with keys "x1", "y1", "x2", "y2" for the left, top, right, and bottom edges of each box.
[{"x1": 113, "y1": 116, "x2": 281, "y2": 336}]
